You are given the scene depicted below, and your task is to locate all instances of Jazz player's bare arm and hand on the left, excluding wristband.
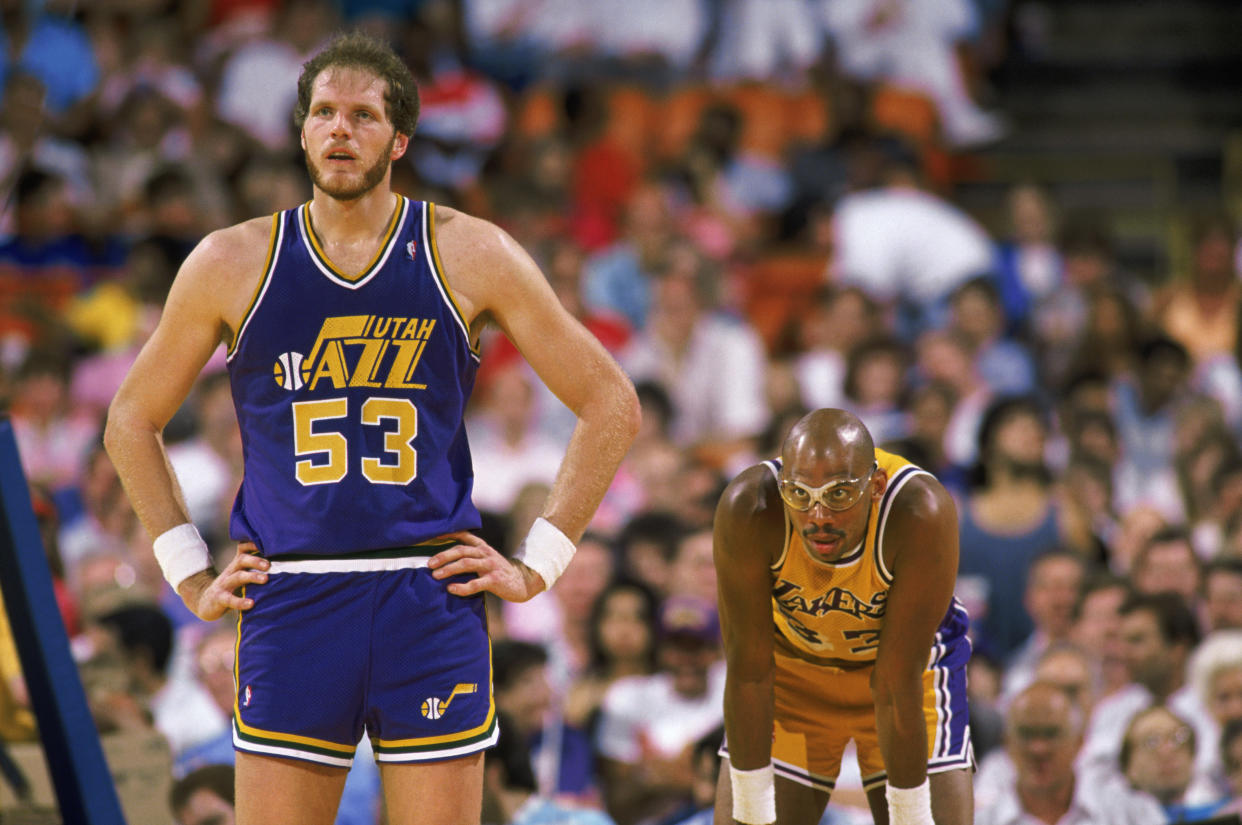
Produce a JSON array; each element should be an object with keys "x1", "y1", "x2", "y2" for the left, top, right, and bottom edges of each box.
[{"x1": 104, "y1": 221, "x2": 270, "y2": 619}]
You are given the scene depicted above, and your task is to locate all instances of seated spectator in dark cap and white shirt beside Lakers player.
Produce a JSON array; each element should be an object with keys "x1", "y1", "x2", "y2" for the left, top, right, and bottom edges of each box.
[{"x1": 596, "y1": 593, "x2": 724, "y2": 825}]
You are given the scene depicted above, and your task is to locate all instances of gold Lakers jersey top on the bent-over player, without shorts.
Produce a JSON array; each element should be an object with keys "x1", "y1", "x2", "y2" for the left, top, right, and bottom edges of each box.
[{"x1": 764, "y1": 450, "x2": 929, "y2": 663}]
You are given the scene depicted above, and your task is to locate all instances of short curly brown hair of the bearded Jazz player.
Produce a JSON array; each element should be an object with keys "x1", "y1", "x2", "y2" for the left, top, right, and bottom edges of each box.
[{"x1": 293, "y1": 31, "x2": 419, "y2": 137}]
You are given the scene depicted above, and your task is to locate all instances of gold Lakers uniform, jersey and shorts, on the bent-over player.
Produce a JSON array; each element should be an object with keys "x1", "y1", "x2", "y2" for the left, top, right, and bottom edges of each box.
[{"x1": 722, "y1": 450, "x2": 974, "y2": 793}]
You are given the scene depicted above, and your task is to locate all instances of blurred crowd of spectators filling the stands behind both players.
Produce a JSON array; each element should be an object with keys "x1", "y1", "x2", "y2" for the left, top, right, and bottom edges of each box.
[{"x1": 0, "y1": 0, "x2": 1242, "y2": 825}]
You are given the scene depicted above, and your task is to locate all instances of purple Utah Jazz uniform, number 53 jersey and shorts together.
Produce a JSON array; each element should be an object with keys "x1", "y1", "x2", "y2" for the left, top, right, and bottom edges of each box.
[{"x1": 229, "y1": 196, "x2": 497, "y2": 767}]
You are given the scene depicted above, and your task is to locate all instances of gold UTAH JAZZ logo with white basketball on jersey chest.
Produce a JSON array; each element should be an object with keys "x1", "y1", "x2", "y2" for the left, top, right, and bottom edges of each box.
[{"x1": 272, "y1": 316, "x2": 436, "y2": 390}]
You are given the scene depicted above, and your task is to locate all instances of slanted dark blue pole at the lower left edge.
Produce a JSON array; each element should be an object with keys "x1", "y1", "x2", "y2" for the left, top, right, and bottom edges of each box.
[{"x1": 0, "y1": 419, "x2": 125, "y2": 825}]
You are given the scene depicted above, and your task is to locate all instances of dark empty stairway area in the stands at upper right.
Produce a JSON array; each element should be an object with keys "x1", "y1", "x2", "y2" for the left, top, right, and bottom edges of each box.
[{"x1": 955, "y1": 0, "x2": 1242, "y2": 281}]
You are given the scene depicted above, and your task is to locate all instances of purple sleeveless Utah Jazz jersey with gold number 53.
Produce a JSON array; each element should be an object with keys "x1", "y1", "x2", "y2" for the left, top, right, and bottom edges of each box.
[{"x1": 229, "y1": 198, "x2": 479, "y2": 554}]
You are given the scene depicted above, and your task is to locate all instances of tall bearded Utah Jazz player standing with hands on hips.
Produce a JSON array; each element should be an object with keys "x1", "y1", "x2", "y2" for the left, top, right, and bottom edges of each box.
[{"x1": 106, "y1": 35, "x2": 638, "y2": 825}]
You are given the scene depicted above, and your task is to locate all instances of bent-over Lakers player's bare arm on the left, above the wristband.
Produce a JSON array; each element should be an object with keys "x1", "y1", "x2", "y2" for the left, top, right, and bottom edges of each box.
[{"x1": 713, "y1": 466, "x2": 785, "y2": 770}]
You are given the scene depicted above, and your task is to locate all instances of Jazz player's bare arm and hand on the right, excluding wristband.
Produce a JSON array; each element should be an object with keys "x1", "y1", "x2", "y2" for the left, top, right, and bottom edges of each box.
[{"x1": 433, "y1": 210, "x2": 638, "y2": 598}]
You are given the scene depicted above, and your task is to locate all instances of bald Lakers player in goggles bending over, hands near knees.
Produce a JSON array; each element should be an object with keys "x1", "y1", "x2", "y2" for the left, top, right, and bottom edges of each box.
[{"x1": 714, "y1": 409, "x2": 974, "y2": 825}]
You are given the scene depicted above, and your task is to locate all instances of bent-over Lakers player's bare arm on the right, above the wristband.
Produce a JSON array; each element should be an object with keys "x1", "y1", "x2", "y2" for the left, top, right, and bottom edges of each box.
[{"x1": 872, "y1": 476, "x2": 958, "y2": 788}]
